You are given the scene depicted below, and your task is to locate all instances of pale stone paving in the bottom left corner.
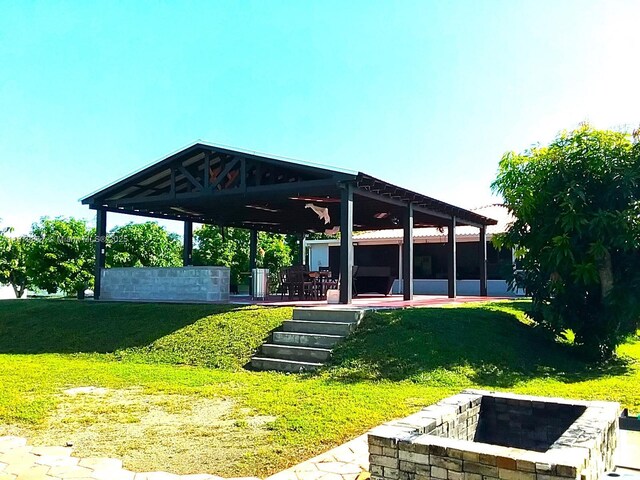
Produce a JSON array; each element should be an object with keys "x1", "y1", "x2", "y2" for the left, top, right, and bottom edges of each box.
[{"x1": 0, "y1": 436, "x2": 257, "y2": 480}]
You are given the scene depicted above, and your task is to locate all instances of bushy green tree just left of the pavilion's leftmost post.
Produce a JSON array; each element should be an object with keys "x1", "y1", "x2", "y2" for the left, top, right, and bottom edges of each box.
[{"x1": 27, "y1": 217, "x2": 95, "y2": 295}]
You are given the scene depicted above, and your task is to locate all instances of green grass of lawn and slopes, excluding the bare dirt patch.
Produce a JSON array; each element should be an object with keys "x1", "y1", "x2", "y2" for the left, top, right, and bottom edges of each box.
[{"x1": 0, "y1": 301, "x2": 640, "y2": 475}]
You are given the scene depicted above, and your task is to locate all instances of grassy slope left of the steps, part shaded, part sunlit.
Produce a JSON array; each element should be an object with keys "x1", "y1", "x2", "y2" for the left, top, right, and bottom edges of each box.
[{"x1": 0, "y1": 300, "x2": 291, "y2": 369}]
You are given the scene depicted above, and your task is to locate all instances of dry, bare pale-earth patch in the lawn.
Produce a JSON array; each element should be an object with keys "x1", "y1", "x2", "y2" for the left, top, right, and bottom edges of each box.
[{"x1": 10, "y1": 387, "x2": 275, "y2": 476}]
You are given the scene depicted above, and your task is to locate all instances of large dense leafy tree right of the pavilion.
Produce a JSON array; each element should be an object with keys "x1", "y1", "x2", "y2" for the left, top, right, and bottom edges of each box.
[{"x1": 492, "y1": 125, "x2": 640, "y2": 359}]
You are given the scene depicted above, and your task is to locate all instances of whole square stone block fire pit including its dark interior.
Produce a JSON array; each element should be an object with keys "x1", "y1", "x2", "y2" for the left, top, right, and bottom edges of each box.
[{"x1": 369, "y1": 390, "x2": 620, "y2": 480}]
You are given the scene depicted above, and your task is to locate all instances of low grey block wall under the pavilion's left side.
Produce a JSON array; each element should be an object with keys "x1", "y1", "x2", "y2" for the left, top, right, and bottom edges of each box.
[{"x1": 100, "y1": 267, "x2": 229, "y2": 302}]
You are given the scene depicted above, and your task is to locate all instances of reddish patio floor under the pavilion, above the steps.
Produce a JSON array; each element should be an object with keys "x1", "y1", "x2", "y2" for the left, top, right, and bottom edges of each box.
[{"x1": 229, "y1": 295, "x2": 513, "y2": 309}]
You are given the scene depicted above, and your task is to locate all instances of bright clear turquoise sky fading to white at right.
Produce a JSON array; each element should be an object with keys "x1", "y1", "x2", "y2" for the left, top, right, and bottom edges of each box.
[{"x1": 0, "y1": 0, "x2": 640, "y2": 233}]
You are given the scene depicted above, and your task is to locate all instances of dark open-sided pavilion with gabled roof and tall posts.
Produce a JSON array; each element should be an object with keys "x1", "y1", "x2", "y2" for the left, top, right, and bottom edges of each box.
[{"x1": 82, "y1": 143, "x2": 496, "y2": 303}]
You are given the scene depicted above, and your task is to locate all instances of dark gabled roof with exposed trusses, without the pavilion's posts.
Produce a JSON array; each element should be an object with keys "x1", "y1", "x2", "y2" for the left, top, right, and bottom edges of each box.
[{"x1": 82, "y1": 143, "x2": 495, "y2": 233}]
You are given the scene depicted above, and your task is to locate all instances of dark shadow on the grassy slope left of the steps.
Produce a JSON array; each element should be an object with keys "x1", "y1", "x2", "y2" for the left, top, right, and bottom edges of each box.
[{"x1": 0, "y1": 299, "x2": 238, "y2": 354}]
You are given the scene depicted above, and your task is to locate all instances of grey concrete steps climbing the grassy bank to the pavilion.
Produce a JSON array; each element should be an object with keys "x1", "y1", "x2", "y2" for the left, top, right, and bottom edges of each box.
[{"x1": 251, "y1": 308, "x2": 365, "y2": 373}]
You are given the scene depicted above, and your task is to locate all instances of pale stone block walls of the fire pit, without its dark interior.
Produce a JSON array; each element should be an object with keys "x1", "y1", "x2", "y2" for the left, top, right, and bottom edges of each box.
[{"x1": 369, "y1": 390, "x2": 619, "y2": 480}]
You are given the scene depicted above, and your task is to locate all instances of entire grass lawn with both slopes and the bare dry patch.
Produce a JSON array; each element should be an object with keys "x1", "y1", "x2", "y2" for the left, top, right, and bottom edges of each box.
[{"x1": 0, "y1": 300, "x2": 640, "y2": 476}]
